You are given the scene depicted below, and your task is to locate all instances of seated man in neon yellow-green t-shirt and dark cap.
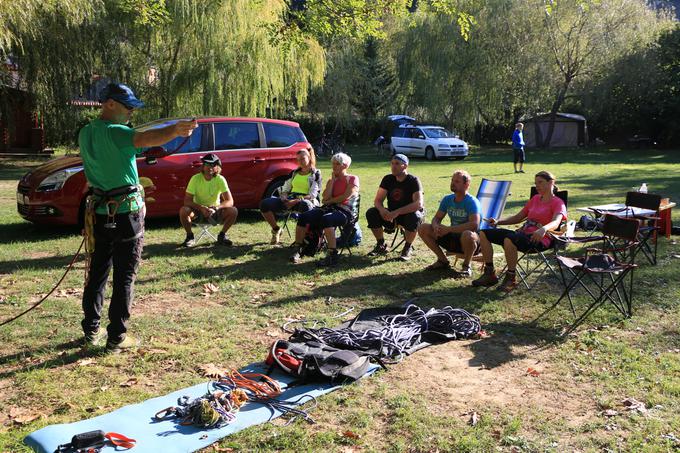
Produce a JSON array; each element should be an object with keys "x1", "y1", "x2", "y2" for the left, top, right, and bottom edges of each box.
[{"x1": 179, "y1": 153, "x2": 238, "y2": 247}]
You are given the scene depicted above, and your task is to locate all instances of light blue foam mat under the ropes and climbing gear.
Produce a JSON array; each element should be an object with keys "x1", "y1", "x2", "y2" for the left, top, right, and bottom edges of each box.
[{"x1": 24, "y1": 363, "x2": 379, "y2": 453}]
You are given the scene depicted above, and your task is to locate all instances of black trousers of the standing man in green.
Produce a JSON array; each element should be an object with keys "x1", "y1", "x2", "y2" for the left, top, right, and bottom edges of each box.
[{"x1": 81, "y1": 209, "x2": 145, "y2": 343}]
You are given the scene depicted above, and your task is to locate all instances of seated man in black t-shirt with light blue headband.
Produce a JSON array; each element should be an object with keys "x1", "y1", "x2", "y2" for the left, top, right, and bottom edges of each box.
[{"x1": 366, "y1": 154, "x2": 423, "y2": 261}]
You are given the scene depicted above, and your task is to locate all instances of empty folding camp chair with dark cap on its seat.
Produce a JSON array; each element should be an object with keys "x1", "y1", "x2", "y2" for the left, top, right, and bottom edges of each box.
[{"x1": 547, "y1": 214, "x2": 640, "y2": 333}]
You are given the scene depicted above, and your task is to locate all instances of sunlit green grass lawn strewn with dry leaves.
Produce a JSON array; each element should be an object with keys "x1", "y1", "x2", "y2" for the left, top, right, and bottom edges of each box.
[{"x1": 0, "y1": 148, "x2": 680, "y2": 452}]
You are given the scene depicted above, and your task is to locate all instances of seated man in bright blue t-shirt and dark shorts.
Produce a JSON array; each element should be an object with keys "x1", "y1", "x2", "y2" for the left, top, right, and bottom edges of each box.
[{"x1": 418, "y1": 170, "x2": 481, "y2": 278}]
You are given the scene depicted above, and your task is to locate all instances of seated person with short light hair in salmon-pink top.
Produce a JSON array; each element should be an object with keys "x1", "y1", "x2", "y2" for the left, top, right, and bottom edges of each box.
[{"x1": 290, "y1": 153, "x2": 359, "y2": 266}]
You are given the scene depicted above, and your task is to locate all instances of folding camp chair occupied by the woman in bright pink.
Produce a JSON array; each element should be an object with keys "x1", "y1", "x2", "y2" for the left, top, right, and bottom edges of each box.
[{"x1": 517, "y1": 187, "x2": 576, "y2": 290}]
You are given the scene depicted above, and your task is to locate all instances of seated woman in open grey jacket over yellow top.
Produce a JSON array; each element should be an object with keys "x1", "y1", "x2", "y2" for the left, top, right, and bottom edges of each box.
[{"x1": 260, "y1": 148, "x2": 321, "y2": 245}]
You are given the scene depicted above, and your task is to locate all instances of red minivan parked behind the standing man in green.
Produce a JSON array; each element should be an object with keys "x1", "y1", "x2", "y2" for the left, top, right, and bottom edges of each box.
[{"x1": 17, "y1": 117, "x2": 310, "y2": 225}]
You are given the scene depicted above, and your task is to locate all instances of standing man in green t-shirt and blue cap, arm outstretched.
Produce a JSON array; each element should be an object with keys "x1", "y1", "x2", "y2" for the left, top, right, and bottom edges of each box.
[{"x1": 78, "y1": 83, "x2": 198, "y2": 352}]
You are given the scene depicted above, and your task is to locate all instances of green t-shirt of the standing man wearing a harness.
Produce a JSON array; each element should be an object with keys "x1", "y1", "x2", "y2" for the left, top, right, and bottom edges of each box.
[{"x1": 78, "y1": 119, "x2": 144, "y2": 214}]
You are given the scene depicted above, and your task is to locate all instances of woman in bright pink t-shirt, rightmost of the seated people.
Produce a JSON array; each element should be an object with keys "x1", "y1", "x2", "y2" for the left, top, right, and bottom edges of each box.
[{"x1": 472, "y1": 171, "x2": 567, "y2": 292}]
